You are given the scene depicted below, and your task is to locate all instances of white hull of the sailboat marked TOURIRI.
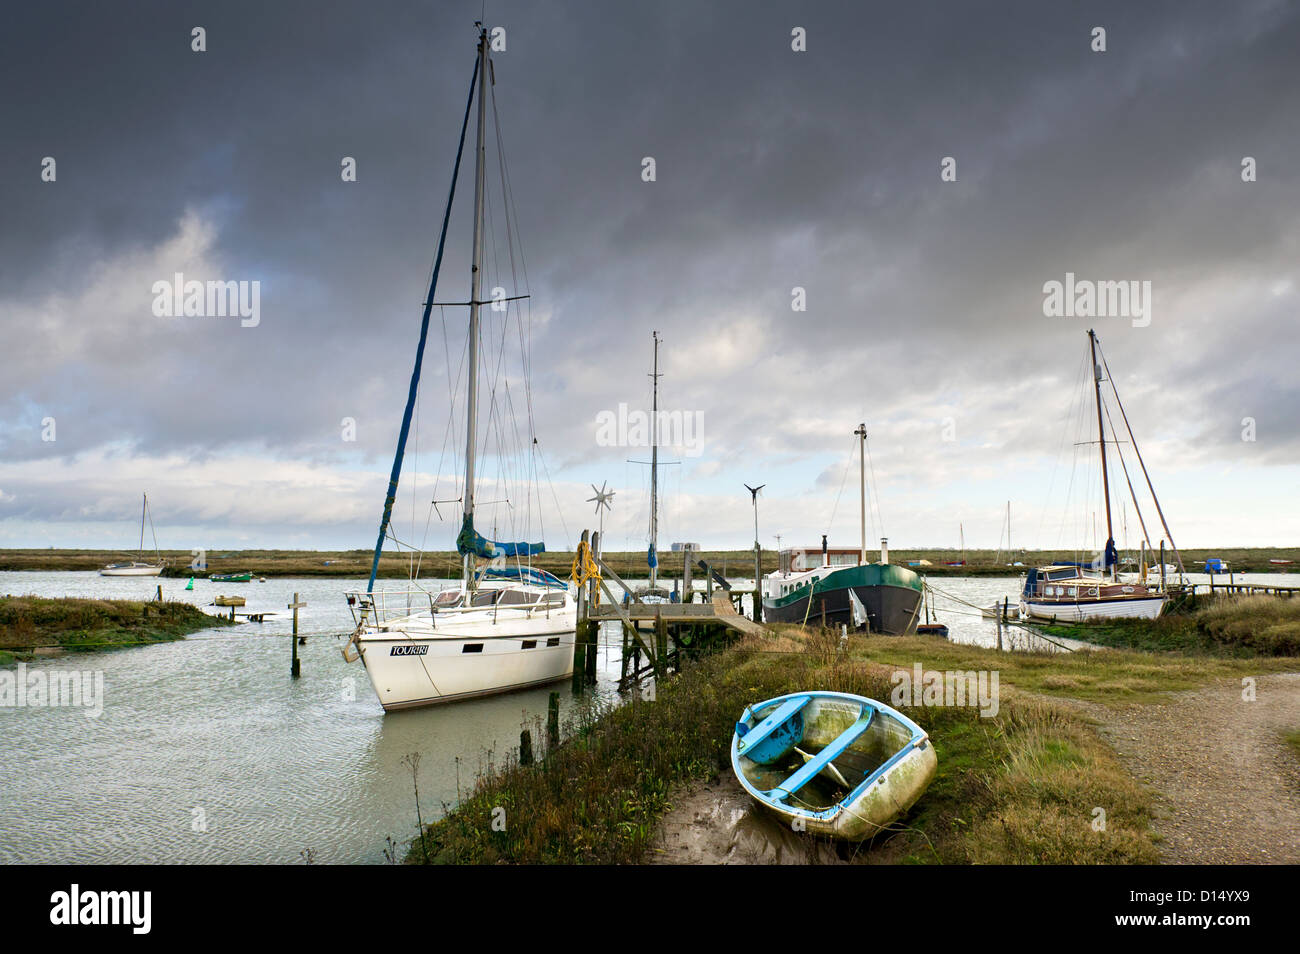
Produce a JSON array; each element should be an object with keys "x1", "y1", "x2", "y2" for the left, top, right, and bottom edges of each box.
[{"x1": 358, "y1": 612, "x2": 576, "y2": 712}]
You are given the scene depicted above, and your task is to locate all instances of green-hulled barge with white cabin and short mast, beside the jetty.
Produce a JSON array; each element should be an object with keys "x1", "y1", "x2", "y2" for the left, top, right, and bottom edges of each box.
[{"x1": 763, "y1": 424, "x2": 924, "y2": 636}]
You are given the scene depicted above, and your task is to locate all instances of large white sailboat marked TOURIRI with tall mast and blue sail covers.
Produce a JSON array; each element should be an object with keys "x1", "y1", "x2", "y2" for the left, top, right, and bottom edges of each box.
[{"x1": 343, "y1": 23, "x2": 577, "y2": 711}]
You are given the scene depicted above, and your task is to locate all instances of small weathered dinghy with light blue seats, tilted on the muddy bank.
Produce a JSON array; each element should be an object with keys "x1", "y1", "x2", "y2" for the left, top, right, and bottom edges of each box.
[{"x1": 732, "y1": 691, "x2": 937, "y2": 841}]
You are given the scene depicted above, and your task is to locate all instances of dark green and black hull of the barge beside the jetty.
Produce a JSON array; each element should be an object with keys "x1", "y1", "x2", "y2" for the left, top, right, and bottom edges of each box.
[{"x1": 763, "y1": 564, "x2": 922, "y2": 636}]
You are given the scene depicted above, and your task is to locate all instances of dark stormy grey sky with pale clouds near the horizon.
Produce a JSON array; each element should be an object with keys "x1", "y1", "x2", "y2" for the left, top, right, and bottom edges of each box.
[{"x1": 0, "y1": 0, "x2": 1300, "y2": 550}]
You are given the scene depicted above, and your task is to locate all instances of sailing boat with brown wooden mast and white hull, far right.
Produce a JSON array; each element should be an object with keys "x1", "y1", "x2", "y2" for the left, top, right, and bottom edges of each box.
[{"x1": 1021, "y1": 330, "x2": 1182, "y2": 621}]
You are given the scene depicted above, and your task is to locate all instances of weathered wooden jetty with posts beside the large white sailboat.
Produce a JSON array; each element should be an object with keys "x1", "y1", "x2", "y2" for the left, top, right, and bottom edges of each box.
[{"x1": 573, "y1": 530, "x2": 767, "y2": 691}]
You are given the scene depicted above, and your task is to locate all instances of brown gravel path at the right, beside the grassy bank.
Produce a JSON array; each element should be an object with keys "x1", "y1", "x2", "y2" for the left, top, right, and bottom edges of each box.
[{"x1": 1086, "y1": 673, "x2": 1300, "y2": 864}]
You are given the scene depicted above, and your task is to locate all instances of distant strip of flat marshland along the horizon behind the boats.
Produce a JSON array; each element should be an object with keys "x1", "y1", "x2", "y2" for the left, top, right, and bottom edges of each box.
[{"x1": 0, "y1": 547, "x2": 1300, "y2": 580}]
